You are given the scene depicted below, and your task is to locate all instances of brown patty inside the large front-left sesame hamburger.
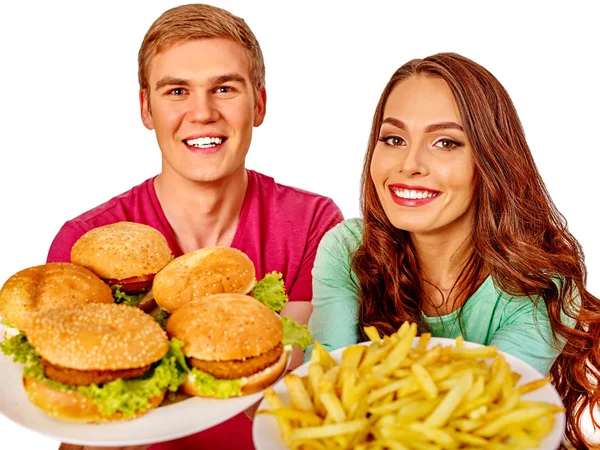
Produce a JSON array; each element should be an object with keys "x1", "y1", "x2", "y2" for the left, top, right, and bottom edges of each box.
[{"x1": 40, "y1": 358, "x2": 150, "y2": 386}]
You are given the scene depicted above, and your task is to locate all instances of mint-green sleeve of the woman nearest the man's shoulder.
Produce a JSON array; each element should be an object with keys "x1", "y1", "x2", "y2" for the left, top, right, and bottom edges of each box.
[{"x1": 304, "y1": 222, "x2": 359, "y2": 361}]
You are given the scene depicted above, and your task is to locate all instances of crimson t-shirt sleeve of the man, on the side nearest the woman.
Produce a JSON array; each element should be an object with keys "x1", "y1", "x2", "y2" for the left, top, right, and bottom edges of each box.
[{"x1": 287, "y1": 199, "x2": 344, "y2": 301}]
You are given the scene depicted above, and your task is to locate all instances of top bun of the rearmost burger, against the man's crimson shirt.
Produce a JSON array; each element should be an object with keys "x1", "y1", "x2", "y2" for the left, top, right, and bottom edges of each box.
[{"x1": 71, "y1": 222, "x2": 171, "y2": 280}]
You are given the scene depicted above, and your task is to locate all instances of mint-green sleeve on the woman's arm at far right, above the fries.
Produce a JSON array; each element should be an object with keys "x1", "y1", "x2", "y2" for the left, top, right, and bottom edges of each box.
[{"x1": 489, "y1": 298, "x2": 564, "y2": 375}]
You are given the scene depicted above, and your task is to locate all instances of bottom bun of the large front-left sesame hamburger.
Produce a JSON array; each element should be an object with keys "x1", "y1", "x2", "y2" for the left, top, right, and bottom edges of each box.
[{"x1": 23, "y1": 377, "x2": 165, "y2": 423}]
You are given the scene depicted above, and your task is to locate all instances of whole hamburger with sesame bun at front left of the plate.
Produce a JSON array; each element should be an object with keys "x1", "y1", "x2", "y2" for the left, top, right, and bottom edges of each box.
[{"x1": 1, "y1": 303, "x2": 183, "y2": 423}]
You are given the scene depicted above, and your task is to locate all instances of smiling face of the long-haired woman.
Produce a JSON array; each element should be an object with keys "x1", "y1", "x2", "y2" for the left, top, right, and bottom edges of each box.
[{"x1": 371, "y1": 76, "x2": 475, "y2": 234}]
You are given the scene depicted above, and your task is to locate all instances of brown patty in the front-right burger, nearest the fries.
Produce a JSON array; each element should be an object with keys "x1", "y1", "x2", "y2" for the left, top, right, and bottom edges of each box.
[{"x1": 189, "y1": 342, "x2": 283, "y2": 380}]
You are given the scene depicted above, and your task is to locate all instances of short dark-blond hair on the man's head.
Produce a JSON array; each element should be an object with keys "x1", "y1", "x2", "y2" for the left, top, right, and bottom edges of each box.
[{"x1": 138, "y1": 4, "x2": 265, "y2": 91}]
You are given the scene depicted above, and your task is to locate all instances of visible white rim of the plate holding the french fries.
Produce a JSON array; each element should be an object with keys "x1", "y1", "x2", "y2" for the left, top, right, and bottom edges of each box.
[{"x1": 252, "y1": 337, "x2": 565, "y2": 450}]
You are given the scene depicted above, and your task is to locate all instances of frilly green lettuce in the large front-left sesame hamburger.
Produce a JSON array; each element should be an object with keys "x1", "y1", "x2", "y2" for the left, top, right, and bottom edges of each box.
[{"x1": 1, "y1": 334, "x2": 189, "y2": 417}]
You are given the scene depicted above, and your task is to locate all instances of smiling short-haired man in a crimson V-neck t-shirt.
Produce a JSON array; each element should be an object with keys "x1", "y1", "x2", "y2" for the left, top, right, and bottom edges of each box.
[{"x1": 48, "y1": 4, "x2": 342, "y2": 449}]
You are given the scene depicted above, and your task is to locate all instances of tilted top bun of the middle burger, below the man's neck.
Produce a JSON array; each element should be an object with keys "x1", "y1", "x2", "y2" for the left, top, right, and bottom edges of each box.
[{"x1": 152, "y1": 247, "x2": 256, "y2": 312}]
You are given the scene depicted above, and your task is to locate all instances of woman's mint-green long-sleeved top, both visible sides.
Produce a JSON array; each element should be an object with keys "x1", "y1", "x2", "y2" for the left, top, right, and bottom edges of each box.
[{"x1": 305, "y1": 219, "x2": 562, "y2": 375}]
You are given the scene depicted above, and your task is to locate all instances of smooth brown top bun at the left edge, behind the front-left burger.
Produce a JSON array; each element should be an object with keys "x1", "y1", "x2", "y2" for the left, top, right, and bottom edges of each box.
[{"x1": 0, "y1": 262, "x2": 114, "y2": 330}]
